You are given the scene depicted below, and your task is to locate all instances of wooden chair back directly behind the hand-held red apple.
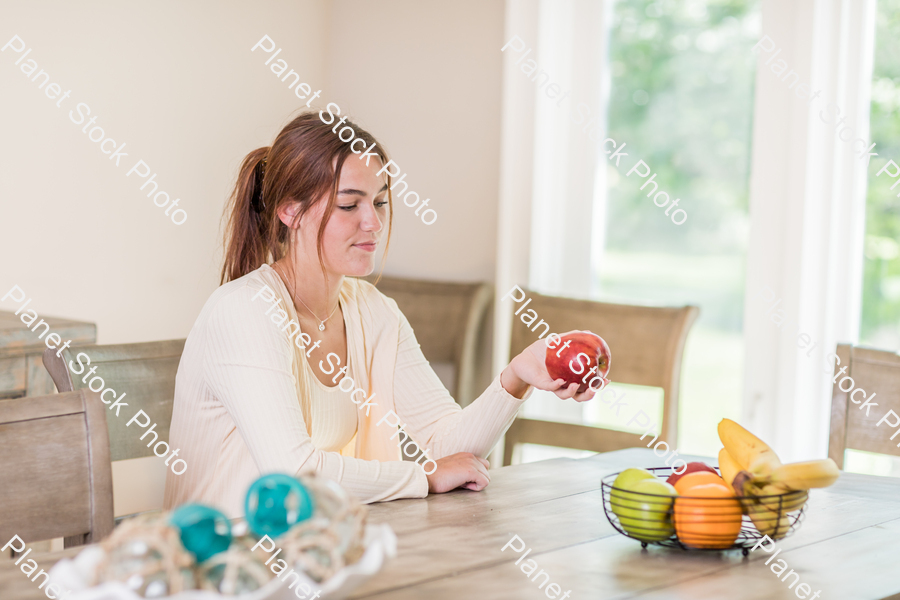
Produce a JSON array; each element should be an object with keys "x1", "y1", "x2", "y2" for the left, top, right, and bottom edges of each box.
[{"x1": 503, "y1": 290, "x2": 700, "y2": 466}]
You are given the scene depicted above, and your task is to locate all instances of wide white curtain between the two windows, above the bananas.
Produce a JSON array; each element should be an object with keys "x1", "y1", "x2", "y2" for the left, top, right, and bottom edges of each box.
[{"x1": 743, "y1": 0, "x2": 877, "y2": 460}]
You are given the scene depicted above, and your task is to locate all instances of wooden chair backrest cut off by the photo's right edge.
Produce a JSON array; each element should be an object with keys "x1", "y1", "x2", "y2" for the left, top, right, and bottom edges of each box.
[{"x1": 828, "y1": 344, "x2": 900, "y2": 469}]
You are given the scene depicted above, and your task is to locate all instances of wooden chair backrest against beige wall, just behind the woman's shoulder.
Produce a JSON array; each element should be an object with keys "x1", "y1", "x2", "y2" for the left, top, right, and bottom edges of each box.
[{"x1": 367, "y1": 276, "x2": 492, "y2": 406}]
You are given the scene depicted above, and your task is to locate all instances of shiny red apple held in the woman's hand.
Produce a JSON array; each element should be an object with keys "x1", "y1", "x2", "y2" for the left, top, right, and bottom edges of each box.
[{"x1": 544, "y1": 331, "x2": 610, "y2": 394}]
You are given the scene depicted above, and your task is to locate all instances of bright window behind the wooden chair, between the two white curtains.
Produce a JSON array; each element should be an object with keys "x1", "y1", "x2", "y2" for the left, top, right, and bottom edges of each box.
[{"x1": 522, "y1": 0, "x2": 759, "y2": 461}]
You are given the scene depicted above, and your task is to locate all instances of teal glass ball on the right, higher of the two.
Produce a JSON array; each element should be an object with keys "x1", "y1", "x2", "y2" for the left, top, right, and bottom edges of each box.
[{"x1": 244, "y1": 473, "x2": 315, "y2": 538}]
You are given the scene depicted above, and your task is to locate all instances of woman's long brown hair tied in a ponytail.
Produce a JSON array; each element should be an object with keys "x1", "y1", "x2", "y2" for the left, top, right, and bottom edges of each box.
[{"x1": 221, "y1": 111, "x2": 394, "y2": 283}]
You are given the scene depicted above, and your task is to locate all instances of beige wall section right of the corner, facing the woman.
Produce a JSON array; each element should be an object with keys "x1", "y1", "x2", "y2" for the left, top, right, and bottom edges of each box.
[{"x1": 323, "y1": 0, "x2": 504, "y2": 281}]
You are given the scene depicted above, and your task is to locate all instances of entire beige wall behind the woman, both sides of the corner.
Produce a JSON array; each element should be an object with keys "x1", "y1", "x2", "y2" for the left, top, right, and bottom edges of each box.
[{"x1": 0, "y1": 0, "x2": 503, "y2": 514}]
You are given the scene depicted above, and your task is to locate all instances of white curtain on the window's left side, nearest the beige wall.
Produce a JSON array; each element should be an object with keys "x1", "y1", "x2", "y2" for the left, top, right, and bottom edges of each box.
[{"x1": 523, "y1": 0, "x2": 612, "y2": 298}]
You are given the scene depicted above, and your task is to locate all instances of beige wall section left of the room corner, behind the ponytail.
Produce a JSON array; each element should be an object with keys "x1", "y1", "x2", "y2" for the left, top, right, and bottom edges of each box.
[{"x1": 0, "y1": 0, "x2": 325, "y2": 343}]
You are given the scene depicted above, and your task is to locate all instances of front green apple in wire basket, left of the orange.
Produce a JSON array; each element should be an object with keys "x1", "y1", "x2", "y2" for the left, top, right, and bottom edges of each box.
[{"x1": 613, "y1": 477, "x2": 678, "y2": 542}]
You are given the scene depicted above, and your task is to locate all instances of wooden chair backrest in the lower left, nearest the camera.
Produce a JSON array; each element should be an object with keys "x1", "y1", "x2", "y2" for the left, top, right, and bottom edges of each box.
[{"x1": 0, "y1": 390, "x2": 113, "y2": 547}]
